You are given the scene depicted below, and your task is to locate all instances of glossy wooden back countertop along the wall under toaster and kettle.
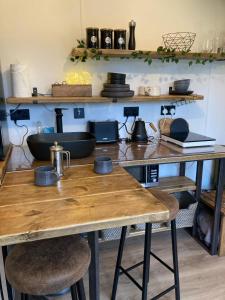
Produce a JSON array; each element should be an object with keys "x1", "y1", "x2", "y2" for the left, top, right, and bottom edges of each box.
[{"x1": 4, "y1": 142, "x2": 225, "y2": 170}]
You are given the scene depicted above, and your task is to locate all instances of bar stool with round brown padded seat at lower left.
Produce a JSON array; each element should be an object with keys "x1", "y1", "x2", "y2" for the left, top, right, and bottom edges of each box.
[{"x1": 5, "y1": 236, "x2": 91, "y2": 300}]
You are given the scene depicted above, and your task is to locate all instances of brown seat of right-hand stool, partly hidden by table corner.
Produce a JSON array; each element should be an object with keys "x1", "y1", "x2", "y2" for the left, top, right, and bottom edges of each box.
[{"x1": 150, "y1": 189, "x2": 179, "y2": 222}]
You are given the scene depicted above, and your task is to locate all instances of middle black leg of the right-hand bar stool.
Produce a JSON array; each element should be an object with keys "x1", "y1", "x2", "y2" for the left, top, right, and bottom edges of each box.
[{"x1": 142, "y1": 223, "x2": 152, "y2": 300}]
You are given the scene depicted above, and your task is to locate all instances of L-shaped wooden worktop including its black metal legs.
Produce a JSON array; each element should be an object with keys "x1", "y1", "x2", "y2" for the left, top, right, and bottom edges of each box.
[{"x1": 0, "y1": 143, "x2": 225, "y2": 299}]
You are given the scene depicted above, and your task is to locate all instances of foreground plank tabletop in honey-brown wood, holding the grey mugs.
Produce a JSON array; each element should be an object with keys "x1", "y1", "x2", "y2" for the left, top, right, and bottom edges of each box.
[{"x1": 0, "y1": 165, "x2": 169, "y2": 245}]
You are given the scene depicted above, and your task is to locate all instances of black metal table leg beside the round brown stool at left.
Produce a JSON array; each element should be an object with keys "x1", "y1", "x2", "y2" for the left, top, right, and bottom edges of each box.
[{"x1": 88, "y1": 231, "x2": 100, "y2": 300}]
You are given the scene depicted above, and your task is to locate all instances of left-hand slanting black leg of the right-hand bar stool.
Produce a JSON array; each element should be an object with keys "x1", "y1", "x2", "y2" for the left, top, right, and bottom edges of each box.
[{"x1": 111, "y1": 226, "x2": 127, "y2": 300}]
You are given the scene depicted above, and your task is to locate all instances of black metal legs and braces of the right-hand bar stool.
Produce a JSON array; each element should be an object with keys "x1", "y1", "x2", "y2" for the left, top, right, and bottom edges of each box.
[{"x1": 111, "y1": 220, "x2": 180, "y2": 300}]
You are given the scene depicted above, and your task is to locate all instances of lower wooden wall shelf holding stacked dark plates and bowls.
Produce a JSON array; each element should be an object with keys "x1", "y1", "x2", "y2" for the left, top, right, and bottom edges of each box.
[{"x1": 6, "y1": 94, "x2": 204, "y2": 104}]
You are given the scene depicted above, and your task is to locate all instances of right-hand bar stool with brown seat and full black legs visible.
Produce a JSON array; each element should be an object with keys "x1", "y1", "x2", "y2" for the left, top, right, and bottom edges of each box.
[{"x1": 111, "y1": 189, "x2": 180, "y2": 300}]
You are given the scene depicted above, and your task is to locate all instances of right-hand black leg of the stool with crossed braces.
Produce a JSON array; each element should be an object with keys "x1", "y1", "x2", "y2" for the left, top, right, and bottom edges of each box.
[{"x1": 171, "y1": 220, "x2": 180, "y2": 300}]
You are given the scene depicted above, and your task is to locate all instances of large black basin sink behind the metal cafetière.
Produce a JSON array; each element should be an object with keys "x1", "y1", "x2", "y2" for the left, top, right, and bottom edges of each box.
[{"x1": 27, "y1": 132, "x2": 95, "y2": 160}]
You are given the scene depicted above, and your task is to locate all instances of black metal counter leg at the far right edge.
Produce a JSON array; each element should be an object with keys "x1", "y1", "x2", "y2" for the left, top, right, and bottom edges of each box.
[{"x1": 210, "y1": 158, "x2": 225, "y2": 255}]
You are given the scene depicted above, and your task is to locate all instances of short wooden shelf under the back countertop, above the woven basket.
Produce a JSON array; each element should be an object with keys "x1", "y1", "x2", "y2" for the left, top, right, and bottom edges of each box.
[{"x1": 154, "y1": 176, "x2": 196, "y2": 194}]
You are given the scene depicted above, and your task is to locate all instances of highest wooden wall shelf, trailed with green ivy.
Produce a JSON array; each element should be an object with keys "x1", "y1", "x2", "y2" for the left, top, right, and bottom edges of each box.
[{"x1": 71, "y1": 48, "x2": 225, "y2": 61}]
